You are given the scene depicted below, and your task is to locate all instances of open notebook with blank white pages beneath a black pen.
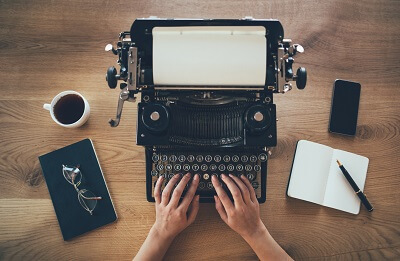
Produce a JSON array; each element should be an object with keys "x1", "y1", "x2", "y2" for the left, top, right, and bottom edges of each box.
[{"x1": 286, "y1": 140, "x2": 369, "y2": 214}]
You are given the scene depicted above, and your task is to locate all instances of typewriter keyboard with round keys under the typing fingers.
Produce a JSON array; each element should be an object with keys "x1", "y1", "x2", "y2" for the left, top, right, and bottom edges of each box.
[{"x1": 146, "y1": 151, "x2": 268, "y2": 202}]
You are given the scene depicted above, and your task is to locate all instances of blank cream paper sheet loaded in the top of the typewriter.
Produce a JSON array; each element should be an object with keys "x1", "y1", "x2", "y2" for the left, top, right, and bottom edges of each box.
[{"x1": 152, "y1": 26, "x2": 267, "y2": 86}]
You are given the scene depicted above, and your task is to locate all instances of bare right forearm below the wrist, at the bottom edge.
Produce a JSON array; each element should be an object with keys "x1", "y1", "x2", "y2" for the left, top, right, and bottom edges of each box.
[{"x1": 243, "y1": 226, "x2": 292, "y2": 260}]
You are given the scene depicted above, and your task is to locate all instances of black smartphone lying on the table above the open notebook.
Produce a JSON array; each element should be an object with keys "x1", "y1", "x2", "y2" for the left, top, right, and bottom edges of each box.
[{"x1": 329, "y1": 79, "x2": 361, "y2": 135}]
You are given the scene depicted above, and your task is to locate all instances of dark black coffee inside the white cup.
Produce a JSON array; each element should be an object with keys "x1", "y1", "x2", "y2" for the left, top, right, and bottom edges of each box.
[{"x1": 54, "y1": 94, "x2": 85, "y2": 124}]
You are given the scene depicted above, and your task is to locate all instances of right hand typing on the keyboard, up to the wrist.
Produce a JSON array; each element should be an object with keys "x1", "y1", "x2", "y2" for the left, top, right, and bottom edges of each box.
[{"x1": 211, "y1": 174, "x2": 266, "y2": 239}]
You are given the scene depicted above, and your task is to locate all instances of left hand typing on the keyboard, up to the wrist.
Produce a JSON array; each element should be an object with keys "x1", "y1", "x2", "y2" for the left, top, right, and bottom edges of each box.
[{"x1": 153, "y1": 173, "x2": 199, "y2": 238}]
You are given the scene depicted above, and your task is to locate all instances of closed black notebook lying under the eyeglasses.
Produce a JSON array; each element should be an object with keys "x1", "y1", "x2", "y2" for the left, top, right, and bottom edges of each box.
[{"x1": 39, "y1": 139, "x2": 117, "y2": 240}]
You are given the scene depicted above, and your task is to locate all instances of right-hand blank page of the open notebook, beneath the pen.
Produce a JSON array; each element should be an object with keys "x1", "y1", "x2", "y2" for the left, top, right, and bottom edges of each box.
[{"x1": 323, "y1": 150, "x2": 369, "y2": 214}]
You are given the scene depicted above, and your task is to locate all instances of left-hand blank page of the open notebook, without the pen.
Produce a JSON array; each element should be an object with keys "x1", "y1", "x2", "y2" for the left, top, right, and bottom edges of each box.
[{"x1": 287, "y1": 140, "x2": 333, "y2": 204}]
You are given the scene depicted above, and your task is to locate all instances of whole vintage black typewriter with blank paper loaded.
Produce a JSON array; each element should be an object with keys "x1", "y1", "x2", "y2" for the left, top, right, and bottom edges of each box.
[{"x1": 105, "y1": 17, "x2": 307, "y2": 203}]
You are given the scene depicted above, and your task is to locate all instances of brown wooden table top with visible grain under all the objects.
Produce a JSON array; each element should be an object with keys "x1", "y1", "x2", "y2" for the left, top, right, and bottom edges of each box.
[{"x1": 0, "y1": 0, "x2": 400, "y2": 260}]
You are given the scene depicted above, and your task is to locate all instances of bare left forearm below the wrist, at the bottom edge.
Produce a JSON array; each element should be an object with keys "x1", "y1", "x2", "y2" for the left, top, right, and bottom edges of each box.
[{"x1": 133, "y1": 226, "x2": 174, "y2": 260}]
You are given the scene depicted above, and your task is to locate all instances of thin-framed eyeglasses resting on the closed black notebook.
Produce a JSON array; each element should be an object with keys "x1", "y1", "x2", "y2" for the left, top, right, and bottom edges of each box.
[{"x1": 62, "y1": 164, "x2": 101, "y2": 215}]
